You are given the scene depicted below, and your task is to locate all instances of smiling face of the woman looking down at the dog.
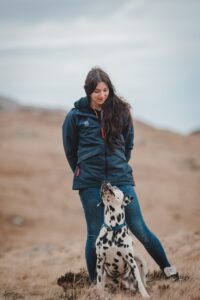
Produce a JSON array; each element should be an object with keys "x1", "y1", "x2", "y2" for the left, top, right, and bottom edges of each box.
[{"x1": 90, "y1": 81, "x2": 109, "y2": 108}]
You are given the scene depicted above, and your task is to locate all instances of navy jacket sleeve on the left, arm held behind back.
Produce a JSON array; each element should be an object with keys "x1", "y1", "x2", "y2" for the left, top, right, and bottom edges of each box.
[{"x1": 62, "y1": 110, "x2": 78, "y2": 172}]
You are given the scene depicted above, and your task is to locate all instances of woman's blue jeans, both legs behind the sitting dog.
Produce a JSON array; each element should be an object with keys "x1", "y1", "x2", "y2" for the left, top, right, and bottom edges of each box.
[{"x1": 79, "y1": 185, "x2": 170, "y2": 282}]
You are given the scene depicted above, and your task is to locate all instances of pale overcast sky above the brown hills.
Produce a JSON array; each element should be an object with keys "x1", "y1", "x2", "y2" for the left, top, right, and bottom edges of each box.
[{"x1": 0, "y1": 0, "x2": 200, "y2": 133}]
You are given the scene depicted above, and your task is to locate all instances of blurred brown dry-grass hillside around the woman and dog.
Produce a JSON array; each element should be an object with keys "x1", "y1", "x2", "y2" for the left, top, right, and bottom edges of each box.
[{"x1": 0, "y1": 109, "x2": 200, "y2": 300}]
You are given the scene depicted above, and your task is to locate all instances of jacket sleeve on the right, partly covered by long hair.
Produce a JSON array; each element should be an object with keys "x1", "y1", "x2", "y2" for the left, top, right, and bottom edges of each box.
[{"x1": 122, "y1": 118, "x2": 134, "y2": 162}]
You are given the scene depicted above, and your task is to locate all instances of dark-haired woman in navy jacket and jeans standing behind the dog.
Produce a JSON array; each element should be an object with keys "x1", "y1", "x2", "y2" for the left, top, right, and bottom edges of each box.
[{"x1": 63, "y1": 68, "x2": 179, "y2": 282}]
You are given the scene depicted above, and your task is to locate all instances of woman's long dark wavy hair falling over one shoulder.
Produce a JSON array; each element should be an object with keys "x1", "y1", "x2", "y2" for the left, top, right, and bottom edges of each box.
[{"x1": 84, "y1": 67, "x2": 132, "y2": 150}]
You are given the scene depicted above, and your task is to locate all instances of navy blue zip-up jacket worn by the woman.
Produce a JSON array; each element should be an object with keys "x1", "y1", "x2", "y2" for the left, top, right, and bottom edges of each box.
[{"x1": 63, "y1": 97, "x2": 134, "y2": 190}]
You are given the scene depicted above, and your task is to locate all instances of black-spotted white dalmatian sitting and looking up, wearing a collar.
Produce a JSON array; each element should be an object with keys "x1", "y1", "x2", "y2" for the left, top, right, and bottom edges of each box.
[{"x1": 96, "y1": 182, "x2": 150, "y2": 298}]
